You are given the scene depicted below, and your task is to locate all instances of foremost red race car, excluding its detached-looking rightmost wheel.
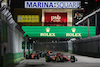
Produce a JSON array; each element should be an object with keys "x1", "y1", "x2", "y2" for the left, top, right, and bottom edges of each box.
[{"x1": 45, "y1": 53, "x2": 70, "y2": 62}]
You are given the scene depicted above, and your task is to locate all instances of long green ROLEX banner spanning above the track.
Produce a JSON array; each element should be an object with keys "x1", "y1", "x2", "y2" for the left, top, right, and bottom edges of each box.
[{"x1": 22, "y1": 26, "x2": 96, "y2": 38}]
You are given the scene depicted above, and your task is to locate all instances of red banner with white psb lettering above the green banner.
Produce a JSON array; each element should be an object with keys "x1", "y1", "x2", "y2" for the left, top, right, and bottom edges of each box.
[{"x1": 44, "y1": 12, "x2": 67, "y2": 26}]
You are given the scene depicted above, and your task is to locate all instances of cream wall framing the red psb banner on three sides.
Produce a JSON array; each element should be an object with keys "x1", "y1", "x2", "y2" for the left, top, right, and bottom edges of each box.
[{"x1": 42, "y1": 9, "x2": 72, "y2": 26}]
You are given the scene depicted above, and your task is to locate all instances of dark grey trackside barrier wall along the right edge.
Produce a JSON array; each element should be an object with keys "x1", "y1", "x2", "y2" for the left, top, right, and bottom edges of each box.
[{"x1": 72, "y1": 35, "x2": 100, "y2": 57}]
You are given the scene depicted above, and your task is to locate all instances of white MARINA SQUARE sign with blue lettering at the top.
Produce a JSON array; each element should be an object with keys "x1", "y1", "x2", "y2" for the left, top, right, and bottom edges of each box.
[{"x1": 25, "y1": 1, "x2": 81, "y2": 9}]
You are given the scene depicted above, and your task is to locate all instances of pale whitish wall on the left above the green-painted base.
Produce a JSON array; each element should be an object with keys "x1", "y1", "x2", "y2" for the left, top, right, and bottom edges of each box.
[{"x1": 7, "y1": 27, "x2": 24, "y2": 53}]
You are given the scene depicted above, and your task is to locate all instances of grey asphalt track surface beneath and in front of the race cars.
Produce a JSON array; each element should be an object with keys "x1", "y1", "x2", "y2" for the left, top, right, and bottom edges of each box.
[{"x1": 8, "y1": 52, "x2": 100, "y2": 67}]
